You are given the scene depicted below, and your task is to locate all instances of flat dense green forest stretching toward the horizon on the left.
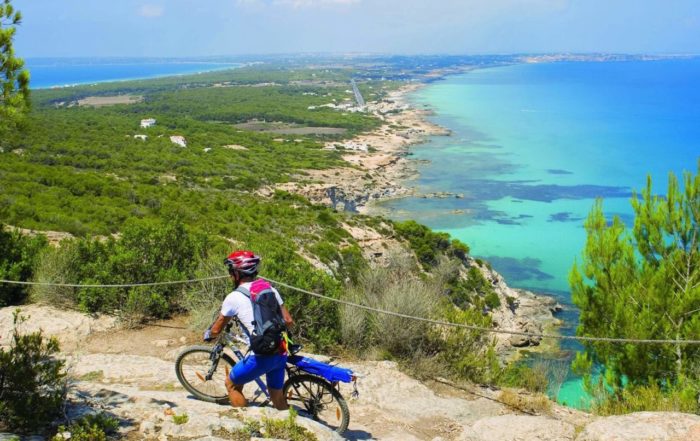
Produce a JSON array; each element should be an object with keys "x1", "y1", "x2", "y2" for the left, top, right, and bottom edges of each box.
[{"x1": 0, "y1": 68, "x2": 382, "y2": 235}]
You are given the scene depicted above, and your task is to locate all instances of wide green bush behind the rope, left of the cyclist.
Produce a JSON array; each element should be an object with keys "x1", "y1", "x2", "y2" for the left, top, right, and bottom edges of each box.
[{"x1": 32, "y1": 220, "x2": 209, "y2": 322}]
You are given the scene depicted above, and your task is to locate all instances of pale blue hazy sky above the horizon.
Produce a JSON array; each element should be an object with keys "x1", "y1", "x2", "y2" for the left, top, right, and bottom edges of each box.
[{"x1": 13, "y1": 0, "x2": 700, "y2": 58}]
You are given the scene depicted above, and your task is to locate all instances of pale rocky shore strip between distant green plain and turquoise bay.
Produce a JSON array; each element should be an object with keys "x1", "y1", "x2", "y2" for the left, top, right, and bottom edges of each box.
[{"x1": 276, "y1": 84, "x2": 450, "y2": 213}]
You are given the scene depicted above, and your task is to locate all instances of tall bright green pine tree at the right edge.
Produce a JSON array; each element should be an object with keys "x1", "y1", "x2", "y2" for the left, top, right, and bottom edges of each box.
[{"x1": 569, "y1": 162, "x2": 700, "y2": 388}]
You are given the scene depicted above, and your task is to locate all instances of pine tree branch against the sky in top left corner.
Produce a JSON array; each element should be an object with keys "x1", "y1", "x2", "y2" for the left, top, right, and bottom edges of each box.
[{"x1": 0, "y1": 0, "x2": 29, "y2": 133}]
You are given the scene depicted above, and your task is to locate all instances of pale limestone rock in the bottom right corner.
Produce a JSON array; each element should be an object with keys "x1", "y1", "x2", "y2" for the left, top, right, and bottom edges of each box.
[{"x1": 576, "y1": 412, "x2": 700, "y2": 441}]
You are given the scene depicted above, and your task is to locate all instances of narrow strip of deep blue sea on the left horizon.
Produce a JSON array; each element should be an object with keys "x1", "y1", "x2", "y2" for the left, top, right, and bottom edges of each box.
[{"x1": 25, "y1": 58, "x2": 241, "y2": 89}]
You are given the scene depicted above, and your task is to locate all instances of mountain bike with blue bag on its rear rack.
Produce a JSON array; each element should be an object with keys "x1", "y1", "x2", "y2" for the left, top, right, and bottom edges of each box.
[{"x1": 175, "y1": 319, "x2": 358, "y2": 434}]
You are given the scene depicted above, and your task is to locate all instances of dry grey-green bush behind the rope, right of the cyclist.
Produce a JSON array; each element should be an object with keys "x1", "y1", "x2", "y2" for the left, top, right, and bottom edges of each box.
[{"x1": 340, "y1": 251, "x2": 498, "y2": 381}]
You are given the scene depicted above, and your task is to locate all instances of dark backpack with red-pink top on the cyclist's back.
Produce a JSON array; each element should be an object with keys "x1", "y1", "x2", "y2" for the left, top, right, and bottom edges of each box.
[{"x1": 236, "y1": 279, "x2": 287, "y2": 355}]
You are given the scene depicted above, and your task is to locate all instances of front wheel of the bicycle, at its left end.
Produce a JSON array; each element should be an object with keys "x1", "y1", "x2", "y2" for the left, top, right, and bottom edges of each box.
[{"x1": 175, "y1": 346, "x2": 233, "y2": 403}]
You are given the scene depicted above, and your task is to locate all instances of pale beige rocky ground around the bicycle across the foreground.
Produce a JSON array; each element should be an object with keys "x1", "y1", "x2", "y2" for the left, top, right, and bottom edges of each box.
[{"x1": 0, "y1": 306, "x2": 700, "y2": 441}]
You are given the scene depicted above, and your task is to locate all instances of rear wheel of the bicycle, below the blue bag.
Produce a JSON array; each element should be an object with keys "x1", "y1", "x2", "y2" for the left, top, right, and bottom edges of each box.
[{"x1": 284, "y1": 375, "x2": 350, "y2": 434}]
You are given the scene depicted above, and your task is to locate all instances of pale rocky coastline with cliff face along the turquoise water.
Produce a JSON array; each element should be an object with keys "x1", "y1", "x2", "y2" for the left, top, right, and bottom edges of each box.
[{"x1": 277, "y1": 77, "x2": 561, "y2": 359}]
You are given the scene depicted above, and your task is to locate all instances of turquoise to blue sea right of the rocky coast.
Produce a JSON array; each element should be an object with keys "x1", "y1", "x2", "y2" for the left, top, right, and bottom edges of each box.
[{"x1": 381, "y1": 59, "x2": 700, "y2": 404}]
